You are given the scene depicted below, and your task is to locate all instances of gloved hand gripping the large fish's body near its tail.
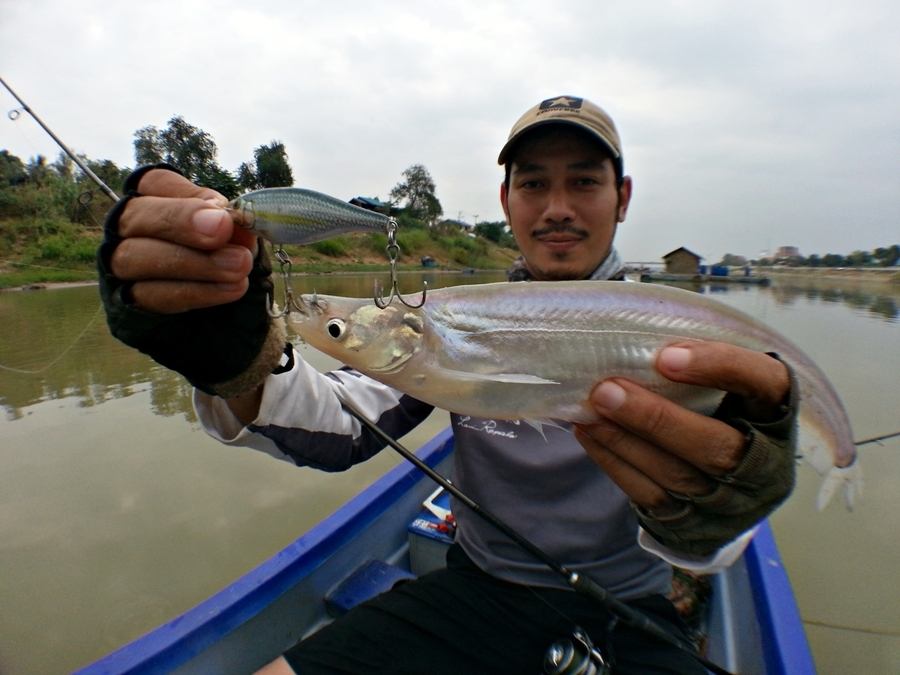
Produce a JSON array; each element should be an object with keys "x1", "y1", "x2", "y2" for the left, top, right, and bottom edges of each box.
[{"x1": 575, "y1": 342, "x2": 796, "y2": 555}]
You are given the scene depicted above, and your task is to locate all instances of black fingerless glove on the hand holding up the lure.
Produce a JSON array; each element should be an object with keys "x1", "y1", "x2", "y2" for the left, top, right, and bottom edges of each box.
[{"x1": 97, "y1": 164, "x2": 286, "y2": 398}]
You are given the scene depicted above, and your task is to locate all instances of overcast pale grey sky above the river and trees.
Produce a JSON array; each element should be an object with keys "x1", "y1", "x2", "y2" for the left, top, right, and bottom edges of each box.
[{"x1": 0, "y1": 0, "x2": 900, "y2": 263}]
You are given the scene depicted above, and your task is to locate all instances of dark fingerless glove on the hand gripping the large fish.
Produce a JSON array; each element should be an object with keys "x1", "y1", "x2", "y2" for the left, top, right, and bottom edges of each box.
[{"x1": 634, "y1": 354, "x2": 797, "y2": 556}]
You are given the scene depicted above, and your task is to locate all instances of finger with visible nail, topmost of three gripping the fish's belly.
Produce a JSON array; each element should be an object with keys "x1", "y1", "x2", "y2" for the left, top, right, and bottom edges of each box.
[{"x1": 590, "y1": 378, "x2": 746, "y2": 475}]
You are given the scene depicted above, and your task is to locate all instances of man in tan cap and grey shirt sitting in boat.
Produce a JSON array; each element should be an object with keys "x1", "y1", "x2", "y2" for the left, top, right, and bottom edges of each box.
[{"x1": 99, "y1": 96, "x2": 795, "y2": 675}]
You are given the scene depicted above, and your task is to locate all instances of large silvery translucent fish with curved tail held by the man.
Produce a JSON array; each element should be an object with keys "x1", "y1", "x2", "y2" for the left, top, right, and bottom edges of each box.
[{"x1": 293, "y1": 281, "x2": 861, "y2": 508}]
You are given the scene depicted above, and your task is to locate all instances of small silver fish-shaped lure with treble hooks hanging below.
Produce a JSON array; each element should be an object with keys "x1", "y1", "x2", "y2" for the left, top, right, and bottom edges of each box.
[{"x1": 229, "y1": 187, "x2": 390, "y2": 244}]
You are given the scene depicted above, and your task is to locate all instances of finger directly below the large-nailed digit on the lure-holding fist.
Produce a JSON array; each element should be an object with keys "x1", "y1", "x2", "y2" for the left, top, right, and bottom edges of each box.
[{"x1": 110, "y1": 238, "x2": 253, "y2": 283}]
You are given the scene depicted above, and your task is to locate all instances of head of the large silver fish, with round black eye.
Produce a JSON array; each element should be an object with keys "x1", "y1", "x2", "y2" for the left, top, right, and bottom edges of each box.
[{"x1": 291, "y1": 295, "x2": 424, "y2": 375}]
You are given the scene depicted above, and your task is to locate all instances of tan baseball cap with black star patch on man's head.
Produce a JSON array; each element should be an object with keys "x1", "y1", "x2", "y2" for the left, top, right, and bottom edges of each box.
[{"x1": 497, "y1": 96, "x2": 622, "y2": 166}]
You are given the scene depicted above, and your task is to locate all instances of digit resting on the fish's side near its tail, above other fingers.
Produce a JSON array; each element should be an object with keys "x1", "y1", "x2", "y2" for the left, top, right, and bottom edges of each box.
[{"x1": 656, "y1": 342, "x2": 790, "y2": 404}]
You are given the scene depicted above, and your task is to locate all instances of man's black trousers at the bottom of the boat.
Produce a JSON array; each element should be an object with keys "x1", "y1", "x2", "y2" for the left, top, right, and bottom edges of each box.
[{"x1": 285, "y1": 546, "x2": 706, "y2": 675}]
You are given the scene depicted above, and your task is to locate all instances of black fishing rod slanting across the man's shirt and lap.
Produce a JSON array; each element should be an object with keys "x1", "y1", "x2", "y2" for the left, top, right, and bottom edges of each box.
[{"x1": 341, "y1": 398, "x2": 733, "y2": 675}]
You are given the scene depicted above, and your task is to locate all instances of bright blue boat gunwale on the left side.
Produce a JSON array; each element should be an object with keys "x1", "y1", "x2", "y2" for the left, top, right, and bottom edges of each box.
[{"x1": 74, "y1": 427, "x2": 453, "y2": 675}]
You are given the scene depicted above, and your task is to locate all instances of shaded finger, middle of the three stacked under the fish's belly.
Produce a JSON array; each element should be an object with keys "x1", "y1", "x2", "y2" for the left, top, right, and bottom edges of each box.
[{"x1": 580, "y1": 421, "x2": 715, "y2": 495}]
